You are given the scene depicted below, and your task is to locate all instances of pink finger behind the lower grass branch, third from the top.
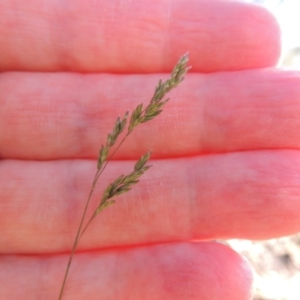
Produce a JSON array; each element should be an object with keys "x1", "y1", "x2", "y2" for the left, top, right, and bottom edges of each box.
[{"x1": 0, "y1": 150, "x2": 300, "y2": 253}]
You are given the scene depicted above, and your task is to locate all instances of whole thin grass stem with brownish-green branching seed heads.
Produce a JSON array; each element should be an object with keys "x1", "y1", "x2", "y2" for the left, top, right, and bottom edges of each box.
[{"x1": 58, "y1": 54, "x2": 189, "y2": 300}]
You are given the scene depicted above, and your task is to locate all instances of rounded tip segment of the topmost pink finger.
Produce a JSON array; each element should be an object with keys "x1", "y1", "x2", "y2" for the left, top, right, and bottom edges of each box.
[{"x1": 170, "y1": 1, "x2": 281, "y2": 72}]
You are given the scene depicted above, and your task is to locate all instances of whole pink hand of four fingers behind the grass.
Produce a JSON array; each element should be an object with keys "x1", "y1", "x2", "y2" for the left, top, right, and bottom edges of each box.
[{"x1": 0, "y1": 0, "x2": 300, "y2": 300}]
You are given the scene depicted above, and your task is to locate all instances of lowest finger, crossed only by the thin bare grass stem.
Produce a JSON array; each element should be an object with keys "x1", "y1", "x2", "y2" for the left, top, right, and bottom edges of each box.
[{"x1": 0, "y1": 243, "x2": 252, "y2": 300}]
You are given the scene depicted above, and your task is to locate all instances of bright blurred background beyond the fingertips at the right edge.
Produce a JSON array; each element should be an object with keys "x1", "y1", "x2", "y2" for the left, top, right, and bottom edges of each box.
[{"x1": 228, "y1": 0, "x2": 300, "y2": 300}]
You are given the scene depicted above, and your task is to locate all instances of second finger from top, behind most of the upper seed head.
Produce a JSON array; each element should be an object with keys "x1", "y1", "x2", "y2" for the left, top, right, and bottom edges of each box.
[{"x1": 0, "y1": 70, "x2": 300, "y2": 159}]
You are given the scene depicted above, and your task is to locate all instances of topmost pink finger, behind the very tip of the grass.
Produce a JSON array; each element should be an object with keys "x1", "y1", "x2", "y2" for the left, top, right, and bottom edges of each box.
[{"x1": 0, "y1": 0, "x2": 280, "y2": 73}]
